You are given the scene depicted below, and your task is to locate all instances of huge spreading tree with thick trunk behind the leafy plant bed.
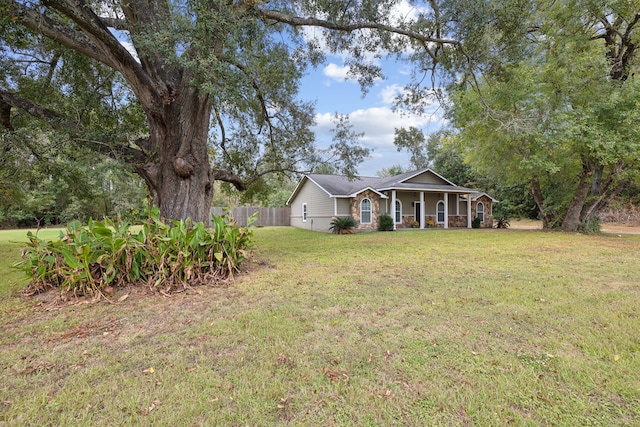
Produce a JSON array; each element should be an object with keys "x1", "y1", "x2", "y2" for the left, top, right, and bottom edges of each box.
[{"x1": 0, "y1": 0, "x2": 459, "y2": 222}]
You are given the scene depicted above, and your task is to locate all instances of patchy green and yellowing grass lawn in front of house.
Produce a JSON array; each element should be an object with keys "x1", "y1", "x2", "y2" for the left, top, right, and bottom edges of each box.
[{"x1": 0, "y1": 228, "x2": 640, "y2": 426}]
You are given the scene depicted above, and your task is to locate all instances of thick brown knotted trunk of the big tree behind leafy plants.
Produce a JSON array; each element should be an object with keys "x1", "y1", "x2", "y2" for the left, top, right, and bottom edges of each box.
[{"x1": 139, "y1": 86, "x2": 213, "y2": 225}]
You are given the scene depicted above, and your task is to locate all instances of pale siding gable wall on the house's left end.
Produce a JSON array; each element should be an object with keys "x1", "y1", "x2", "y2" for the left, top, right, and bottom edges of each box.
[{"x1": 291, "y1": 180, "x2": 334, "y2": 231}]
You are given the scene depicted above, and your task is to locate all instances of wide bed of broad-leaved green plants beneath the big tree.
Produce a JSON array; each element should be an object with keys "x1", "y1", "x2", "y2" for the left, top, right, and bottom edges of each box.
[{"x1": 15, "y1": 208, "x2": 251, "y2": 295}]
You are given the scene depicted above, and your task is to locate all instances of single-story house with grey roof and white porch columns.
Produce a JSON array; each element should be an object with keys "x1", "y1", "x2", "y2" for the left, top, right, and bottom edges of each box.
[{"x1": 287, "y1": 169, "x2": 497, "y2": 231}]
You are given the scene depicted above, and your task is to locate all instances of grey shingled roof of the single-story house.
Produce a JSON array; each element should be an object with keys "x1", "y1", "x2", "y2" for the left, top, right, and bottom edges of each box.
[{"x1": 287, "y1": 169, "x2": 484, "y2": 204}]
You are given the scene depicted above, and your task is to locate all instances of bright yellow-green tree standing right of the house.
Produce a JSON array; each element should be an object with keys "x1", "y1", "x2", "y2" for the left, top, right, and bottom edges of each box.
[{"x1": 451, "y1": 0, "x2": 640, "y2": 230}]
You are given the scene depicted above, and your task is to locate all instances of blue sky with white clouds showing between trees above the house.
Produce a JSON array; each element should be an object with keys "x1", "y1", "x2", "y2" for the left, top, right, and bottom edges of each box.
[{"x1": 300, "y1": 56, "x2": 443, "y2": 176}]
